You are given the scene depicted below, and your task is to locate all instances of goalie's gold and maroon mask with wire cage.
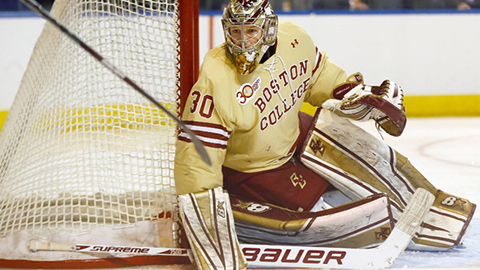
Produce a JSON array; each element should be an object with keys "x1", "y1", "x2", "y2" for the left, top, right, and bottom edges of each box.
[{"x1": 222, "y1": 0, "x2": 278, "y2": 74}]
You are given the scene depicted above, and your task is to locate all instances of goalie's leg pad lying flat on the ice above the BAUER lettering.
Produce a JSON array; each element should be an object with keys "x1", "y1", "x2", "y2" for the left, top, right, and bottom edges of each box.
[{"x1": 231, "y1": 194, "x2": 393, "y2": 248}]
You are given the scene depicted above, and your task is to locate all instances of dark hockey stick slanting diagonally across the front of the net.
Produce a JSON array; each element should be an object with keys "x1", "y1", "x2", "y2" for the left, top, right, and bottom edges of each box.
[{"x1": 21, "y1": 0, "x2": 211, "y2": 165}]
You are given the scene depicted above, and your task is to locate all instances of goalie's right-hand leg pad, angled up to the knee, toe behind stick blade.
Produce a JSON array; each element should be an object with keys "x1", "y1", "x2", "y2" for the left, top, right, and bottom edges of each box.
[{"x1": 301, "y1": 109, "x2": 476, "y2": 250}]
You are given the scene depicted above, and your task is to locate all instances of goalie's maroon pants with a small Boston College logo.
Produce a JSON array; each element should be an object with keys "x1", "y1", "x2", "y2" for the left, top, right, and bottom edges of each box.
[{"x1": 223, "y1": 112, "x2": 329, "y2": 211}]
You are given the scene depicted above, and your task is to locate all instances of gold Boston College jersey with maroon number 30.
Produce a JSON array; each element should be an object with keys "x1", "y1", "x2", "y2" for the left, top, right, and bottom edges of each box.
[{"x1": 175, "y1": 22, "x2": 346, "y2": 194}]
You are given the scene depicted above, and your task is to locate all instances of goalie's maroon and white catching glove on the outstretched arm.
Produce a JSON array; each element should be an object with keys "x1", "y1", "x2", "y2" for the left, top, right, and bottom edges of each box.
[{"x1": 322, "y1": 73, "x2": 407, "y2": 136}]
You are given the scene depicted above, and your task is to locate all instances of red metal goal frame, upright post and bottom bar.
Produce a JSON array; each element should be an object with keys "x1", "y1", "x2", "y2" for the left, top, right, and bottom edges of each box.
[{"x1": 0, "y1": 0, "x2": 200, "y2": 269}]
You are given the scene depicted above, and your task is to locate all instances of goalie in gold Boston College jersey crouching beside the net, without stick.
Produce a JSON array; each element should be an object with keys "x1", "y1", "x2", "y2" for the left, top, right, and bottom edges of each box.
[{"x1": 175, "y1": 0, "x2": 475, "y2": 269}]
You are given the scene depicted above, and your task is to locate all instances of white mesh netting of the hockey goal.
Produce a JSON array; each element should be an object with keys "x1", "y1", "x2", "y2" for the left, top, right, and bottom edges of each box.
[{"x1": 0, "y1": 0, "x2": 195, "y2": 268}]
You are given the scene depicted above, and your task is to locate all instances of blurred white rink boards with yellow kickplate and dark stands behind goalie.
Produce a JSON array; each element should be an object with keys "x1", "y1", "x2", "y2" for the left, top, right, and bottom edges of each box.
[{"x1": 0, "y1": 0, "x2": 480, "y2": 130}]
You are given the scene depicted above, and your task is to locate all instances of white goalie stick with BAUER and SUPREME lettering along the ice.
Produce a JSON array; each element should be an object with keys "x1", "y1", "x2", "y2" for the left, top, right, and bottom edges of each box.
[{"x1": 30, "y1": 188, "x2": 435, "y2": 269}]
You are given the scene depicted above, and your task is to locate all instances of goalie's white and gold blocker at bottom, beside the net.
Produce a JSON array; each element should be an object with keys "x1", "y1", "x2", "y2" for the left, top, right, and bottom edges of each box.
[{"x1": 178, "y1": 187, "x2": 247, "y2": 270}]
